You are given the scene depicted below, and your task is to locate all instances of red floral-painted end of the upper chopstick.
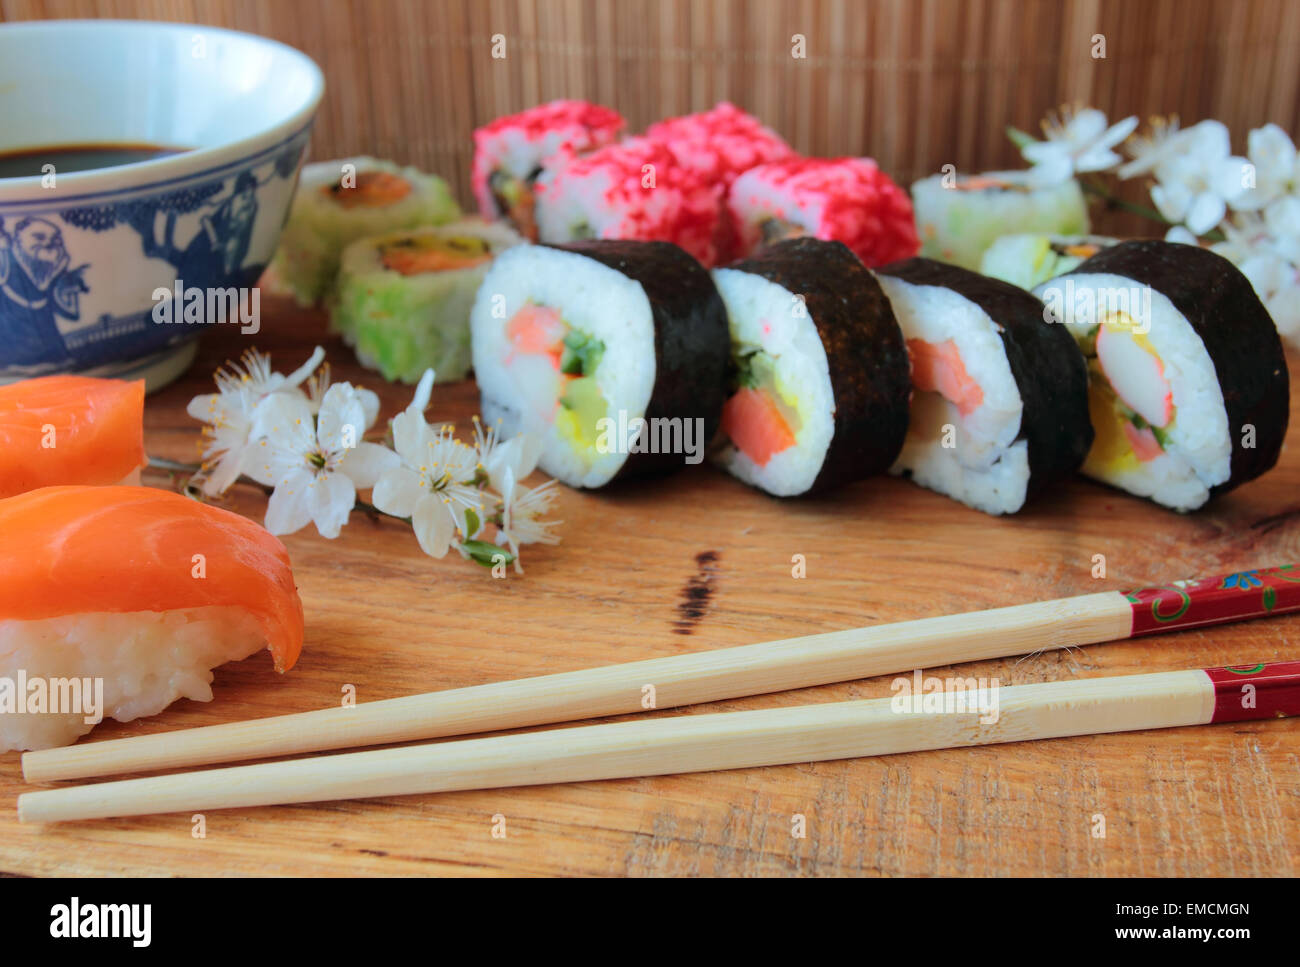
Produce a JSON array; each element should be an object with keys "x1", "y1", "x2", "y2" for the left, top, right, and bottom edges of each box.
[{"x1": 1123, "y1": 564, "x2": 1300, "y2": 636}]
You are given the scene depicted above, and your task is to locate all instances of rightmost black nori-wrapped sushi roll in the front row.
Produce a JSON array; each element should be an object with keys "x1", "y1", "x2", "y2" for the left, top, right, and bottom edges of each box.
[{"x1": 1036, "y1": 240, "x2": 1291, "y2": 511}]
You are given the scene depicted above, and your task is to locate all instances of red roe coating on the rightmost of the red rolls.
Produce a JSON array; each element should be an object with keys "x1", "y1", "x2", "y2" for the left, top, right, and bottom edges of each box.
[{"x1": 732, "y1": 157, "x2": 920, "y2": 268}]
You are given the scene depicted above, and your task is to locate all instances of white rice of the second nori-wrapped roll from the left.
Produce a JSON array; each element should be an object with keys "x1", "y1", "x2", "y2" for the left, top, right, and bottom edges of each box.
[{"x1": 712, "y1": 269, "x2": 835, "y2": 496}]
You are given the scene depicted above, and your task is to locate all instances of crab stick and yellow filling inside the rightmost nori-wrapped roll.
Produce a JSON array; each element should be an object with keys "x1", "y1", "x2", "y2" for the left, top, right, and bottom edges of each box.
[{"x1": 1088, "y1": 312, "x2": 1174, "y2": 468}]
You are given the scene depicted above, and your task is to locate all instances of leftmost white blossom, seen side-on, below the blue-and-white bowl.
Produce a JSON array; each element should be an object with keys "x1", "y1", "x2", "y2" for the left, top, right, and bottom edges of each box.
[{"x1": 186, "y1": 346, "x2": 325, "y2": 496}]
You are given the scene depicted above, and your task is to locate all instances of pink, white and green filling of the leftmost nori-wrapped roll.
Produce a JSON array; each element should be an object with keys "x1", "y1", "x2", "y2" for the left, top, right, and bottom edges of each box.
[{"x1": 506, "y1": 303, "x2": 608, "y2": 450}]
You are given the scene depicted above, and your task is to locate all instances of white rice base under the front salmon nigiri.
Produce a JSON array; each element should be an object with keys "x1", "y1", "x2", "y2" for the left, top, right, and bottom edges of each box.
[{"x1": 0, "y1": 607, "x2": 267, "y2": 753}]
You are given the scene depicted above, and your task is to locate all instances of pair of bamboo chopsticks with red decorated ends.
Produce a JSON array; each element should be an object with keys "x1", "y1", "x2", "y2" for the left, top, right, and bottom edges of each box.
[{"x1": 20, "y1": 565, "x2": 1300, "y2": 821}]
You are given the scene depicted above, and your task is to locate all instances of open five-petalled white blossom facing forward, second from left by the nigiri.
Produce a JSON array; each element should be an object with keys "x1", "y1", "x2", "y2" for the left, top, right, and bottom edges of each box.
[{"x1": 257, "y1": 382, "x2": 398, "y2": 538}]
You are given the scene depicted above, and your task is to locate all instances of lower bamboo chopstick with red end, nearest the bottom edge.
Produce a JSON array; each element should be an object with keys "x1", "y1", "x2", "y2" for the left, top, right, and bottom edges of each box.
[{"x1": 18, "y1": 662, "x2": 1300, "y2": 823}]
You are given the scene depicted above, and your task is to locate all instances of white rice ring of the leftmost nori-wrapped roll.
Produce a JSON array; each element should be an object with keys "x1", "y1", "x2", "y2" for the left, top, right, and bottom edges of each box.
[{"x1": 469, "y1": 244, "x2": 655, "y2": 487}]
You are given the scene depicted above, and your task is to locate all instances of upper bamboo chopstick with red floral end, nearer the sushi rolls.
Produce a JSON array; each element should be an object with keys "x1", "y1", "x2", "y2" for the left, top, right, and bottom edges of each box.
[{"x1": 22, "y1": 564, "x2": 1300, "y2": 782}]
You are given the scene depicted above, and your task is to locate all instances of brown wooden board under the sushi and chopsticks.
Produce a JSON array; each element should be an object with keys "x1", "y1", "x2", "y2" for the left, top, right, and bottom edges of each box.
[{"x1": 0, "y1": 300, "x2": 1300, "y2": 876}]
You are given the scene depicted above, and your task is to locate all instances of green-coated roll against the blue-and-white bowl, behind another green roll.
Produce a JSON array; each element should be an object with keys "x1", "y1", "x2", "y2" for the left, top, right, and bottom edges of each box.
[{"x1": 272, "y1": 157, "x2": 460, "y2": 305}]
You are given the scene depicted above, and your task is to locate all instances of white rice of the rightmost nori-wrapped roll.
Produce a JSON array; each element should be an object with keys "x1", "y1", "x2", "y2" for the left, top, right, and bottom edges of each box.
[{"x1": 1034, "y1": 273, "x2": 1232, "y2": 511}]
